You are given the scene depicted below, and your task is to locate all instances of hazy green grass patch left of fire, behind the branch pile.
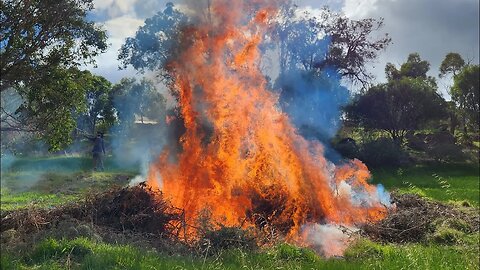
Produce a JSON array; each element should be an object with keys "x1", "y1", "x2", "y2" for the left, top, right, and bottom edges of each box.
[{"x1": 0, "y1": 157, "x2": 138, "y2": 211}]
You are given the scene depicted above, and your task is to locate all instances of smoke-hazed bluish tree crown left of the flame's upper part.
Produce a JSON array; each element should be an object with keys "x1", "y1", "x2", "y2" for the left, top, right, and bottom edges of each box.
[{"x1": 118, "y1": 2, "x2": 187, "y2": 80}]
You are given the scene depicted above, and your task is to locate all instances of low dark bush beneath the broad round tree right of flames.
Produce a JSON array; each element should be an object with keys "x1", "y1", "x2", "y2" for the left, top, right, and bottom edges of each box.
[{"x1": 359, "y1": 138, "x2": 408, "y2": 167}]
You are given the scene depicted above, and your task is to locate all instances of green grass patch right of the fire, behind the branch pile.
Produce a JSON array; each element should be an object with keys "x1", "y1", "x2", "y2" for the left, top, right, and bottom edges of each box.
[{"x1": 372, "y1": 164, "x2": 480, "y2": 206}]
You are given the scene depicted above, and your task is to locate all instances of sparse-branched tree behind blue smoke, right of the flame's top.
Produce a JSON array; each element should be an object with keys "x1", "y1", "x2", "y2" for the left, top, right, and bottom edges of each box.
[{"x1": 277, "y1": 7, "x2": 391, "y2": 87}]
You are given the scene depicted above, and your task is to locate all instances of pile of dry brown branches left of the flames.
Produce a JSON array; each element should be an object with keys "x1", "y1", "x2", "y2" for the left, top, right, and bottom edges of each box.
[{"x1": 0, "y1": 185, "x2": 183, "y2": 236}]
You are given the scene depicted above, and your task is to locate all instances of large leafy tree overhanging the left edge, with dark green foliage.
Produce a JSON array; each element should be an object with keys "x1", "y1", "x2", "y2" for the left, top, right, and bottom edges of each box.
[{"x1": 0, "y1": 0, "x2": 107, "y2": 150}]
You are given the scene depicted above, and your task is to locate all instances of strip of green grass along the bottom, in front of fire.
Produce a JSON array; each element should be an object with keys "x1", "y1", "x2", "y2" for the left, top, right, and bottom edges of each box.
[{"x1": 1, "y1": 238, "x2": 478, "y2": 269}]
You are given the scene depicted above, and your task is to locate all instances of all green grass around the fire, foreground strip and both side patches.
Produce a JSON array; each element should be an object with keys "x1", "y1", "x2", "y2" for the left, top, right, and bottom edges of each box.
[{"x1": 1, "y1": 157, "x2": 479, "y2": 269}]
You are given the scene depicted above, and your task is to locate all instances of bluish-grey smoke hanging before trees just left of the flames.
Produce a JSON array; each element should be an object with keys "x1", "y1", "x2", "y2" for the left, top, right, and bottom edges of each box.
[{"x1": 110, "y1": 79, "x2": 173, "y2": 184}]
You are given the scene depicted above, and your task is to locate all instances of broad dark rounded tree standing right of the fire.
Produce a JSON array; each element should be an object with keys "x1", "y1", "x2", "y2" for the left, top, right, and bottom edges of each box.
[{"x1": 345, "y1": 54, "x2": 447, "y2": 145}]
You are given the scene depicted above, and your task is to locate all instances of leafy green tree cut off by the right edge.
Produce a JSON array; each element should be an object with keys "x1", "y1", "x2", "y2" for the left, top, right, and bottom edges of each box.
[{"x1": 451, "y1": 65, "x2": 480, "y2": 136}]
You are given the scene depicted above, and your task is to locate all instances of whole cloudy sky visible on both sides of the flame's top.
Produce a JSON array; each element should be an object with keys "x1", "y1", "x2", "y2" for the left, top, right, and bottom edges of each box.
[{"x1": 88, "y1": 0, "x2": 480, "y2": 96}]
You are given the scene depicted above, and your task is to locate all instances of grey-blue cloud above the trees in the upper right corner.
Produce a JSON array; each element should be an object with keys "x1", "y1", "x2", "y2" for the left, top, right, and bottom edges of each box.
[{"x1": 343, "y1": 0, "x2": 479, "y2": 96}]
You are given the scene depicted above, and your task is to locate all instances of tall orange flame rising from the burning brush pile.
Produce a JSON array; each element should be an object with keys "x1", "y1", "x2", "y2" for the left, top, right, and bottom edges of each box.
[{"x1": 148, "y1": 0, "x2": 385, "y2": 242}]
